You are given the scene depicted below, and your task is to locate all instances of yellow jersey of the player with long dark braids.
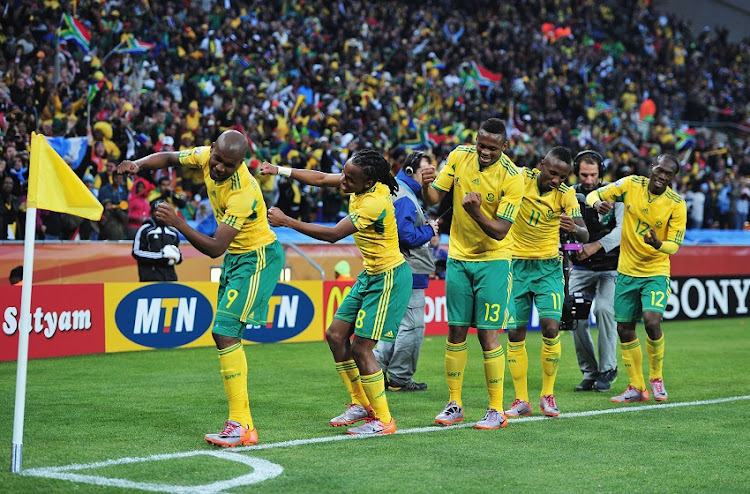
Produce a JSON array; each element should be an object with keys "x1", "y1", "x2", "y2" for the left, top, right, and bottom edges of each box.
[{"x1": 349, "y1": 182, "x2": 405, "y2": 274}]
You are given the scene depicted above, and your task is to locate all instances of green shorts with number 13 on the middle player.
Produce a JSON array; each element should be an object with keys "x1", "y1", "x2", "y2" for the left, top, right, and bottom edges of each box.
[{"x1": 445, "y1": 258, "x2": 515, "y2": 330}]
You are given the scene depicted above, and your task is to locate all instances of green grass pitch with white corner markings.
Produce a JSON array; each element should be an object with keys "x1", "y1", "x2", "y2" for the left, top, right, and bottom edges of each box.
[{"x1": 0, "y1": 319, "x2": 750, "y2": 494}]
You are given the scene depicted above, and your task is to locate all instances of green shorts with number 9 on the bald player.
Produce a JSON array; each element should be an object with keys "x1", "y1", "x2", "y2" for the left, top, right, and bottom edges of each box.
[{"x1": 212, "y1": 240, "x2": 284, "y2": 338}]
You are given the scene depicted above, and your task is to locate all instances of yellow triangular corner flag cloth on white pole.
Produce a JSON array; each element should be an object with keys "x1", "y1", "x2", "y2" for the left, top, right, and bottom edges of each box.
[{"x1": 26, "y1": 132, "x2": 104, "y2": 221}]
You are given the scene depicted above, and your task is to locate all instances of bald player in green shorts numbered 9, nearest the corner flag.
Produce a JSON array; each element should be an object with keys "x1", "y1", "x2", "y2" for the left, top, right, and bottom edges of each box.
[{"x1": 119, "y1": 130, "x2": 284, "y2": 447}]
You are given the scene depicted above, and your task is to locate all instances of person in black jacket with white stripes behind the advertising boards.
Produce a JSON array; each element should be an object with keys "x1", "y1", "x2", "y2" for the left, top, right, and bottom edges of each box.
[{"x1": 133, "y1": 200, "x2": 182, "y2": 281}]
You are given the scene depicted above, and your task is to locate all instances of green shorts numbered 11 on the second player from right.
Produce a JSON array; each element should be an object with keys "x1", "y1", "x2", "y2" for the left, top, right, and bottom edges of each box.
[{"x1": 513, "y1": 258, "x2": 565, "y2": 326}]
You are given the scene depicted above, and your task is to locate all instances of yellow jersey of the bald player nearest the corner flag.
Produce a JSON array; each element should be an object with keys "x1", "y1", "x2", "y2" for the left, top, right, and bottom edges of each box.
[{"x1": 179, "y1": 146, "x2": 276, "y2": 254}]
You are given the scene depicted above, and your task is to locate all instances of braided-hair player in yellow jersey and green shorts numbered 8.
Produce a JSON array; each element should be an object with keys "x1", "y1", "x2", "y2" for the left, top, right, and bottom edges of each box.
[{"x1": 264, "y1": 149, "x2": 412, "y2": 435}]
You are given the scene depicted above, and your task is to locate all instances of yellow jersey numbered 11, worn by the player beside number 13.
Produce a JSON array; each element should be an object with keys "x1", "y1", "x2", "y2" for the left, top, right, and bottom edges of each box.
[{"x1": 510, "y1": 168, "x2": 581, "y2": 259}]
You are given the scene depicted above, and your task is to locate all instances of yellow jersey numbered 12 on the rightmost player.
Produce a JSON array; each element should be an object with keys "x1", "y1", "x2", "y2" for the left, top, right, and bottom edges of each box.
[{"x1": 597, "y1": 175, "x2": 687, "y2": 278}]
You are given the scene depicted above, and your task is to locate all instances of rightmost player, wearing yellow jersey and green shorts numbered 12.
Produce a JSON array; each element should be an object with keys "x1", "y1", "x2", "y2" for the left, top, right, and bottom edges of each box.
[{"x1": 586, "y1": 154, "x2": 687, "y2": 403}]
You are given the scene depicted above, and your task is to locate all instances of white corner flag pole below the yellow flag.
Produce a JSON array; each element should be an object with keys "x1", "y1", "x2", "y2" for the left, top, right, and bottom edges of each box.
[{"x1": 10, "y1": 206, "x2": 36, "y2": 473}]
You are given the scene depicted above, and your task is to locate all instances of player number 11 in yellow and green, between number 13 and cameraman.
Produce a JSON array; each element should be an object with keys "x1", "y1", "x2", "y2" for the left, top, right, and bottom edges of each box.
[{"x1": 505, "y1": 146, "x2": 589, "y2": 418}]
